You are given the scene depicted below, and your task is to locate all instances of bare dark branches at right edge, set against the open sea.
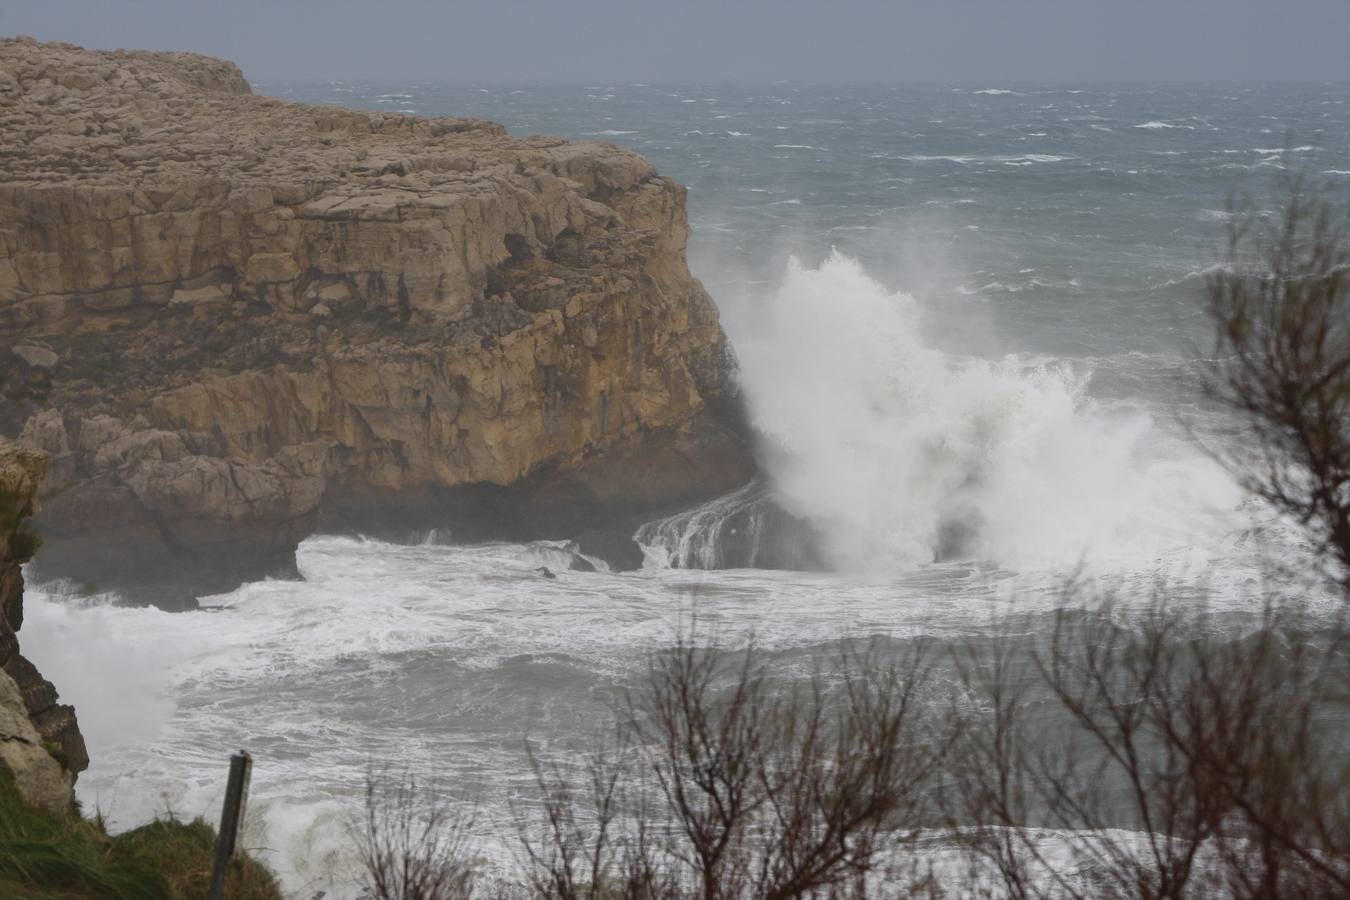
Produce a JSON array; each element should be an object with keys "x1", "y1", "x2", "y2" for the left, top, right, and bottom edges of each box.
[{"x1": 1204, "y1": 178, "x2": 1350, "y2": 588}]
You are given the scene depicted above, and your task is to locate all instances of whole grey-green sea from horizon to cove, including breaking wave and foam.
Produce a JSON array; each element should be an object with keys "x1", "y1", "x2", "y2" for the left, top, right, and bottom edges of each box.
[{"x1": 23, "y1": 82, "x2": 1350, "y2": 896}]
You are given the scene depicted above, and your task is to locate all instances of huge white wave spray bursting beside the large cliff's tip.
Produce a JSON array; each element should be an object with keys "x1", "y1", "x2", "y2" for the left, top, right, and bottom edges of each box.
[{"x1": 740, "y1": 252, "x2": 1241, "y2": 571}]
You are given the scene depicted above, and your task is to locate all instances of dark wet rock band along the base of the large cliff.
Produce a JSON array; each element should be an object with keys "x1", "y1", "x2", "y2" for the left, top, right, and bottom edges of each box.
[{"x1": 36, "y1": 414, "x2": 755, "y2": 610}]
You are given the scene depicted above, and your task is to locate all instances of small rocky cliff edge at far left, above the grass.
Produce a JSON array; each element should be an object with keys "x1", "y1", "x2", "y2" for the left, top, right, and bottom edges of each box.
[{"x1": 0, "y1": 439, "x2": 89, "y2": 812}]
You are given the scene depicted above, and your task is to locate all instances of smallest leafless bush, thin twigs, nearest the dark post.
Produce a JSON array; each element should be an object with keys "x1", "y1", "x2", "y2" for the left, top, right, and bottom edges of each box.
[{"x1": 352, "y1": 772, "x2": 475, "y2": 900}]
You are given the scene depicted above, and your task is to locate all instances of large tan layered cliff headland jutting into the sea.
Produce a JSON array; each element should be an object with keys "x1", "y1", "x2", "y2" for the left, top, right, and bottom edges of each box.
[{"x1": 0, "y1": 39, "x2": 752, "y2": 599}]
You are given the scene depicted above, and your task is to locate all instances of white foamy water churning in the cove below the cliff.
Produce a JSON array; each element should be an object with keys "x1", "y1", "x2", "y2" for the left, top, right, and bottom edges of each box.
[{"x1": 24, "y1": 528, "x2": 1258, "y2": 897}]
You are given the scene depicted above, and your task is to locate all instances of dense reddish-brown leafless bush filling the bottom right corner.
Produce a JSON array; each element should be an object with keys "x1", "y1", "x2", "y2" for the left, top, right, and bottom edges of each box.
[{"x1": 945, "y1": 591, "x2": 1350, "y2": 900}]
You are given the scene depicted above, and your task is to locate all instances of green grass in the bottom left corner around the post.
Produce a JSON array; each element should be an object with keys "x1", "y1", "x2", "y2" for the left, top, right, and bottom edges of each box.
[{"x1": 0, "y1": 766, "x2": 281, "y2": 900}]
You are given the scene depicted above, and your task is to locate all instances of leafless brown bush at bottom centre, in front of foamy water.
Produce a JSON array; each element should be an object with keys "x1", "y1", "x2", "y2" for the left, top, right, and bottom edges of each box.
[{"x1": 510, "y1": 640, "x2": 952, "y2": 900}]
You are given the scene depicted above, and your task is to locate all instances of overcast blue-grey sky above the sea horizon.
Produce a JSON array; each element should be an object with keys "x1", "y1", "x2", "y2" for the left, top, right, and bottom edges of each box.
[{"x1": 0, "y1": 0, "x2": 1350, "y2": 82}]
